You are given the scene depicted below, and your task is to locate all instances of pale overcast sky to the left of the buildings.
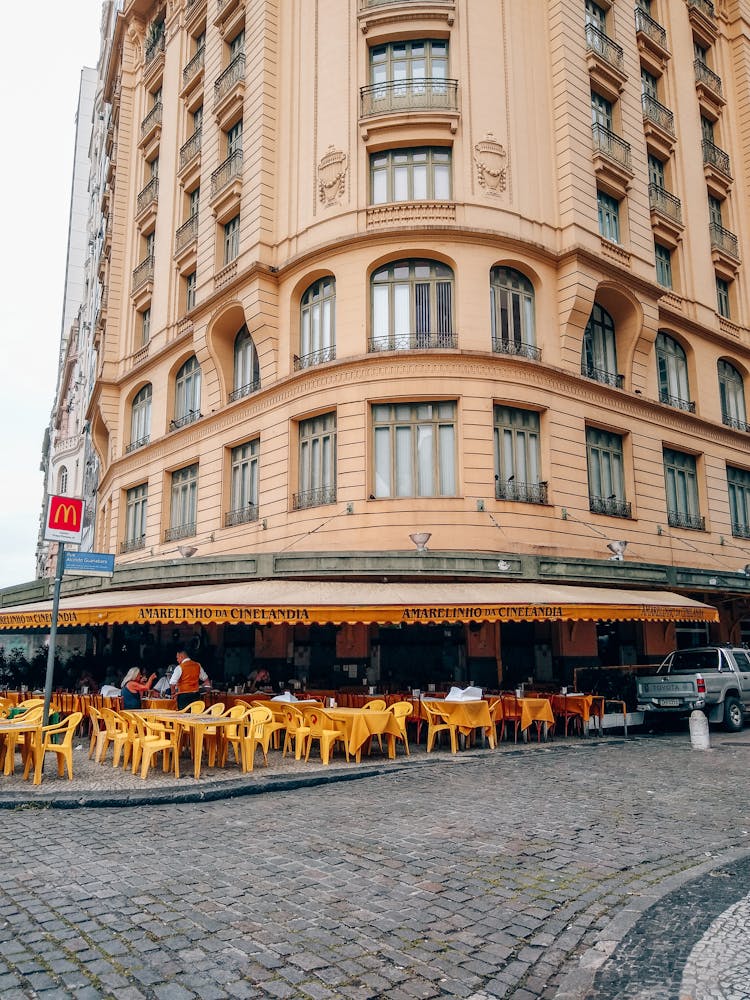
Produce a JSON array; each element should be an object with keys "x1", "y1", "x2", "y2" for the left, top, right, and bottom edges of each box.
[{"x1": 0, "y1": 0, "x2": 101, "y2": 587}]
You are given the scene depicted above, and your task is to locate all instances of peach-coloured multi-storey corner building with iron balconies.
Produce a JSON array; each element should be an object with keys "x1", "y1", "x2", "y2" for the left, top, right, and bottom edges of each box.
[{"x1": 4, "y1": 0, "x2": 750, "y2": 685}]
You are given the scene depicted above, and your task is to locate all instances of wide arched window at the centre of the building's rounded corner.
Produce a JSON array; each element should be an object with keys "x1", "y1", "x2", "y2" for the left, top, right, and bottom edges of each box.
[{"x1": 370, "y1": 260, "x2": 456, "y2": 351}]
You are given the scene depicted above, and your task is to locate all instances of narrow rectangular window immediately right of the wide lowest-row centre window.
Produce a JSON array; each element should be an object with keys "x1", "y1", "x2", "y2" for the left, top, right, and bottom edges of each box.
[{"x1": 494, "y1": 406, "x2": 547, "y2": 503}]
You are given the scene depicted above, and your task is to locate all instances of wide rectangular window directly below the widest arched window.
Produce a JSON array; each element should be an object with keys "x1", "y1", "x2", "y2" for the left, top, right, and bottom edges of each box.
[{"x1": 372, "y1": 402, "x2": 456, "y2": 498}]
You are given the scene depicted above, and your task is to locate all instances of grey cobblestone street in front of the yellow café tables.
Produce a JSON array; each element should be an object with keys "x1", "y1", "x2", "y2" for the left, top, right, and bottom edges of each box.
[{"x1": 0, "y1": 733, "x2": 750, "y2": 1000}]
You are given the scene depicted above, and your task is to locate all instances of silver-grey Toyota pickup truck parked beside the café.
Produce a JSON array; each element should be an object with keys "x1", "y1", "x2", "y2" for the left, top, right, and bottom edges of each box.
[{"x1": 636, "y1": 646, "x2": 750, "y2": 732}]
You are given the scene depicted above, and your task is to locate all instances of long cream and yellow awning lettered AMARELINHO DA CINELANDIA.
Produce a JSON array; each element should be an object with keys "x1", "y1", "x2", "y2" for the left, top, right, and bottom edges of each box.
[{"x1": 0, "y1": 580, "x2": 719, "y2": 630}]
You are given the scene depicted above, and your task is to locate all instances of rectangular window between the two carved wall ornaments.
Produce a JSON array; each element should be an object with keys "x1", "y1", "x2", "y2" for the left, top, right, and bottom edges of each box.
[{"x1": 370, "y1": 146, "x2": 451, "y2": 205}]
